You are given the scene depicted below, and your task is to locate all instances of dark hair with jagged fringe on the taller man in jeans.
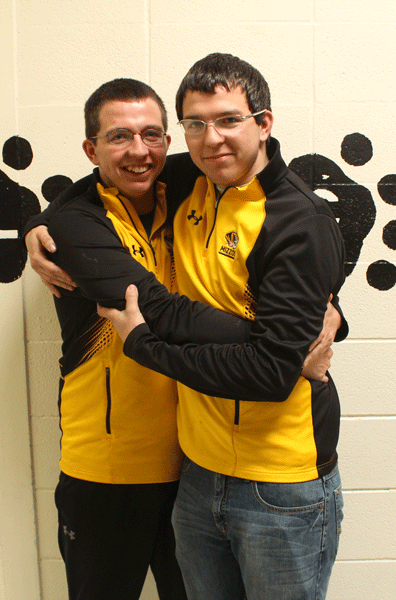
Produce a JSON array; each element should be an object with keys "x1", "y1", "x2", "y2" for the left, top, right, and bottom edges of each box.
[{"x1": 176, "y1": 52, "x2": 271, "y2": 123}]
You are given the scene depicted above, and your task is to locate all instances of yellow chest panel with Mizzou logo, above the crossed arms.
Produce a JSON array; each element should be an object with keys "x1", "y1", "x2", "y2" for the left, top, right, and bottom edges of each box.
[{"x1": 174, "y1": 177, "x2": 265, "y2": 318}]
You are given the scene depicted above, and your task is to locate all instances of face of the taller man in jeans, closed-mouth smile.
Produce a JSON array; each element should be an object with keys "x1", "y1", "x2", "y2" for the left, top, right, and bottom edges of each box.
[{"x1": 183, "y1": 86, "x2": 273, "y2": 187}]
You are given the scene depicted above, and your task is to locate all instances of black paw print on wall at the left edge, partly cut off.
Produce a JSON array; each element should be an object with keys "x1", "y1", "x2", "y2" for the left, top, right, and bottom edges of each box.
[{"x1": 0, "y1": 136, "x2": 72, "y2": 283}]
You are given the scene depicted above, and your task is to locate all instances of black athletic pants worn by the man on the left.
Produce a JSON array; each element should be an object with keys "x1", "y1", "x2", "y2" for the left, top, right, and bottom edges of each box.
[{"x1": 55, "y1": 473, "x2": 187, "y2": 600}]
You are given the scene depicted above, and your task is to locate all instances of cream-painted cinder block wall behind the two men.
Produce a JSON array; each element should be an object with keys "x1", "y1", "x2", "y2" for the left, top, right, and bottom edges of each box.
[{"x1": 0, "y1": 0, "x2": 396, "y2": 600}]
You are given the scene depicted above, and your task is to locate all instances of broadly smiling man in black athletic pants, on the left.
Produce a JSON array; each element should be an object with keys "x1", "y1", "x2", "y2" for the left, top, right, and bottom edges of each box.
[{"x1": 25, "y1": 79, "x2": 256, "y2": 600}]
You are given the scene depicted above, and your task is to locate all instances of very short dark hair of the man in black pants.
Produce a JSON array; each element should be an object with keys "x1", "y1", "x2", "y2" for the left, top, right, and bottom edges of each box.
[{"x1": 84, "y1": 79, "x2": 168, "y2": 139}]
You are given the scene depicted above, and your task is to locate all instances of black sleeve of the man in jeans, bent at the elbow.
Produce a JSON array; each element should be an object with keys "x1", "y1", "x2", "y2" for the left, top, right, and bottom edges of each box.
[{"x1": 124, "y1": 215, "x2": 344, "y2": 401}]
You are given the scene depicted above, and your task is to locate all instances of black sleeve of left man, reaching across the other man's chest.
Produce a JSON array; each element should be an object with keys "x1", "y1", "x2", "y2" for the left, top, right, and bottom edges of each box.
[{"x1": 48, "y1": 200, "x2": 250, "y2": 344}]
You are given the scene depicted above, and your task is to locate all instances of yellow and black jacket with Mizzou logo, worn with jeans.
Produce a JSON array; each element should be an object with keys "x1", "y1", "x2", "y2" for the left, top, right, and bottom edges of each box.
[{"x1": 124, "y1": 139, "x2": 346, "y2": 482}]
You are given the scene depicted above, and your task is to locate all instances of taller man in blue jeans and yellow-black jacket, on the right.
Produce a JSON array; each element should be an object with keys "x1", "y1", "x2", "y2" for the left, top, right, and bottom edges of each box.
[{"x1": 100, "y1": 54, "x2": 344, "y2": 600}]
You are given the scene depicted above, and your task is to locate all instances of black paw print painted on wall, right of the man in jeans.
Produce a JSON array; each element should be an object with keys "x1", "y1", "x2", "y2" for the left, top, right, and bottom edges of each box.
[{"x1": 289, "y1": 133, "x2": 396, "y2": 290}]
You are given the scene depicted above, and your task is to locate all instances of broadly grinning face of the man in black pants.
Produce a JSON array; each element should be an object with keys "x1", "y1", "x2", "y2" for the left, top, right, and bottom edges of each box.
[{"x1": 83, "y1": 98, "x2": 170, "y2": 212}]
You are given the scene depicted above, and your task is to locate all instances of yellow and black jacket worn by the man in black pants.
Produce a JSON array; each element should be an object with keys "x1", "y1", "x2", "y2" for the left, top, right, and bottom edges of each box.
[{"x1": 30, "y1": 170, "x2": 247, "y2": 483}]
